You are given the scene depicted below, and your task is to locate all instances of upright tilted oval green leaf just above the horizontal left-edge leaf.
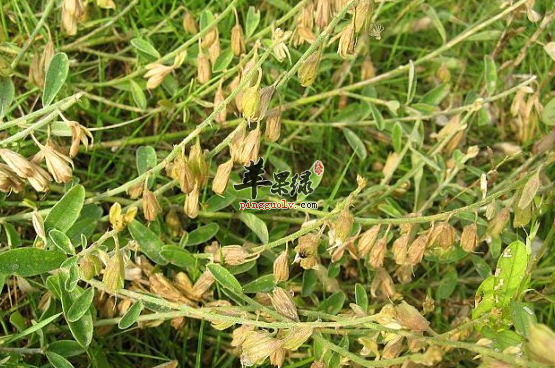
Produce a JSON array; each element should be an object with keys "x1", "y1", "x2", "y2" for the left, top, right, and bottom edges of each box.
[{"x1": 44, "y1": 185, "x2": 85, "y2": 233}]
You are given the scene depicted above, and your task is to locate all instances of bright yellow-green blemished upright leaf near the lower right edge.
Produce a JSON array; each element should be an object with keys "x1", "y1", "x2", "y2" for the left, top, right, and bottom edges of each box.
[{"x1": 495, "y1": 241, "x2": 528, "y2": 307}]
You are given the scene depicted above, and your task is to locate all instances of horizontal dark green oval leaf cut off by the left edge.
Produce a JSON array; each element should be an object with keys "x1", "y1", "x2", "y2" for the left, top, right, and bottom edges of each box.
[{"x1": 0, "y1": 248, "x2": 67, "y2": 277}]
